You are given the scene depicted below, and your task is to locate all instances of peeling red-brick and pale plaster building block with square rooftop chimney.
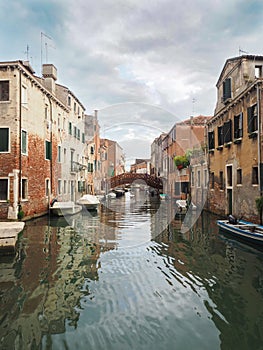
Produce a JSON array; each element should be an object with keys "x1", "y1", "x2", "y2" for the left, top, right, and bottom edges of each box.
[{"x1": 0, "y1": 61, "x2": 87, "y2": 219}]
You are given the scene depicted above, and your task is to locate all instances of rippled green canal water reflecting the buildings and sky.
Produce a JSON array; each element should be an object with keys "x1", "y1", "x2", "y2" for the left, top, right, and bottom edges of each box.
[{"x1": 0, "y1": 194, "x2": 263, "y2": 350}]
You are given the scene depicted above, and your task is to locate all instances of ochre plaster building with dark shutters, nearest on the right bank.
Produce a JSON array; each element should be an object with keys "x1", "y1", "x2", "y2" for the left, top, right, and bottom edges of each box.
[{"x1": 208, "y1": 55, "x2": 263, "y2": 221}]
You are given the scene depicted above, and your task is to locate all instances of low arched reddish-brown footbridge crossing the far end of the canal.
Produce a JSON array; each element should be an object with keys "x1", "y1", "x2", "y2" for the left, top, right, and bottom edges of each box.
[{"x1": 110, "y1": 173, "x2": 163, "y2": 190}]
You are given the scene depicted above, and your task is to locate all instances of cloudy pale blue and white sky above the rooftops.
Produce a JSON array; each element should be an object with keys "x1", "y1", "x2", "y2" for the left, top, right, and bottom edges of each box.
[{"x1": 0, "y1": 0, "x2": 263, "y2": 158}]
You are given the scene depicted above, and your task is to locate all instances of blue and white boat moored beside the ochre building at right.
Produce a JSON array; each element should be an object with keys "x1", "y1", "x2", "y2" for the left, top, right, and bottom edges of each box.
[{"x1": 217, "y1": 219, "x2": 263, "y2": 244}]
